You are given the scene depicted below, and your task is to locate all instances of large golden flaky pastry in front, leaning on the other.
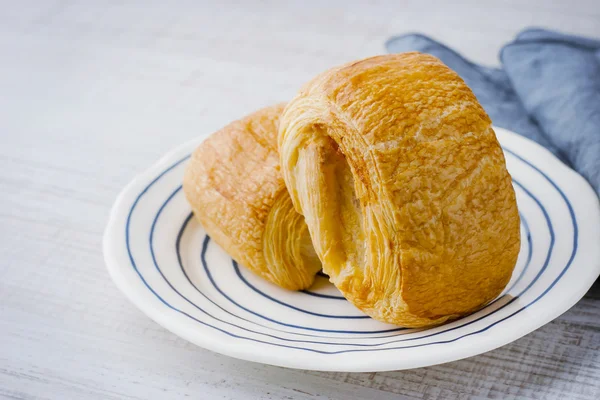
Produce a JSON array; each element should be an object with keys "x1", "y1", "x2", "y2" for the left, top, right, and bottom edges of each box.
[{"x1": 278, "y1": 53, "x2": 520, "y2": 327}]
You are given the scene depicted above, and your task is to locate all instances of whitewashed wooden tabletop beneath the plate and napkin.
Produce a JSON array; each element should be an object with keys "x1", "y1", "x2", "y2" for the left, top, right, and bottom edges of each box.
[{"x1": 0, "y1": 0, "x2": 600, "y2": 399}]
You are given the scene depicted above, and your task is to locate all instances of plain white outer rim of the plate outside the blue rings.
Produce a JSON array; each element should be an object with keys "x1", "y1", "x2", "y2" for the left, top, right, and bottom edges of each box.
[{"x1": 103, "y1": 126, "x2": 600, "y2": 372}]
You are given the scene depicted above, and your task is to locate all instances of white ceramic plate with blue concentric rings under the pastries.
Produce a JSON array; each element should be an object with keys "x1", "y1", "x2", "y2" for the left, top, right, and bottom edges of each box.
[{"x1": 104, "y1": 128, "x2": 600, "y2": 371}]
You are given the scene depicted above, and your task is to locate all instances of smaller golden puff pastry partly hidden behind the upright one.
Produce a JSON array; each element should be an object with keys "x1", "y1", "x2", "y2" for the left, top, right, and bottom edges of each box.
[{"x1": 183, "y1": 105, "x2": 321, "y2": 290}]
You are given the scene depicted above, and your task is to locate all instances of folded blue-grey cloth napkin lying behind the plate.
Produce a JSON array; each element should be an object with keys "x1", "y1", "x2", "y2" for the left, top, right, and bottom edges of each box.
[{"x1": 386, "y1": 29, "x2": 600, "y2": 193}]
